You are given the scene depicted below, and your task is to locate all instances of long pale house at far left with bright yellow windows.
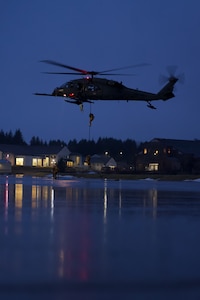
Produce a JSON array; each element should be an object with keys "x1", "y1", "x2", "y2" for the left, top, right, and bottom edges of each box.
[{"x1": 0, "y1": 144, "x2": 70, "y2": 167}]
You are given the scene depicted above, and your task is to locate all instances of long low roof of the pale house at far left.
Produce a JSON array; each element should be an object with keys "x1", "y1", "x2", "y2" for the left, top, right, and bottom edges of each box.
[{"x1": 0, "y1": 144, "x2": 69, "y2": 156}]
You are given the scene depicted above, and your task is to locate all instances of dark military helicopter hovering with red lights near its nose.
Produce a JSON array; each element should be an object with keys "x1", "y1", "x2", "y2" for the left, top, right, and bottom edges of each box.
[{"x1": 35, "y1": 60, "x2": 179, "y2": 110}]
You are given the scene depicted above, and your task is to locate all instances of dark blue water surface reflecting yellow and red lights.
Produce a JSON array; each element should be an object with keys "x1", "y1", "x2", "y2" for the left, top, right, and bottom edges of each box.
[{"x1": 0, "y1": 176, "x2": 200, "y2": 299}]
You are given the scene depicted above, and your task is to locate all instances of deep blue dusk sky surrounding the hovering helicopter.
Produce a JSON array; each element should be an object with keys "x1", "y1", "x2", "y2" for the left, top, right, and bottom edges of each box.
[{"x1": 0, "y1": 0, "x2": 200, "y2": 143}]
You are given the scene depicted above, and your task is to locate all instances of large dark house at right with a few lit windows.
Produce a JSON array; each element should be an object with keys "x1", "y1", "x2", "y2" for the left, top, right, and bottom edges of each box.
[{"x1": 135, "y1": 138, "x2": 200, "y2": 173}]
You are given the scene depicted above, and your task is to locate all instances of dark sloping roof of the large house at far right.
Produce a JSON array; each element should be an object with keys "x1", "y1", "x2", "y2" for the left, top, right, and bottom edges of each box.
[{"x1": 151, "y1": 138, "x2": 200, "y2": 157}]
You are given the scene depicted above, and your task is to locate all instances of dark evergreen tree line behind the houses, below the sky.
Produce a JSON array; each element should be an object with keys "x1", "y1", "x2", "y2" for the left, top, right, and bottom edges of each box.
[{"x1": 0, "y1": 129, "x2": 138, "y2": 162}]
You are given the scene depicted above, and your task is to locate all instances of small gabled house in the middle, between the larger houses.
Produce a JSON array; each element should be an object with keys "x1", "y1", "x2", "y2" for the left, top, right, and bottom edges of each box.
[{"x1": 90, "y1": 154, "x2": 117, "y2": 172}]
